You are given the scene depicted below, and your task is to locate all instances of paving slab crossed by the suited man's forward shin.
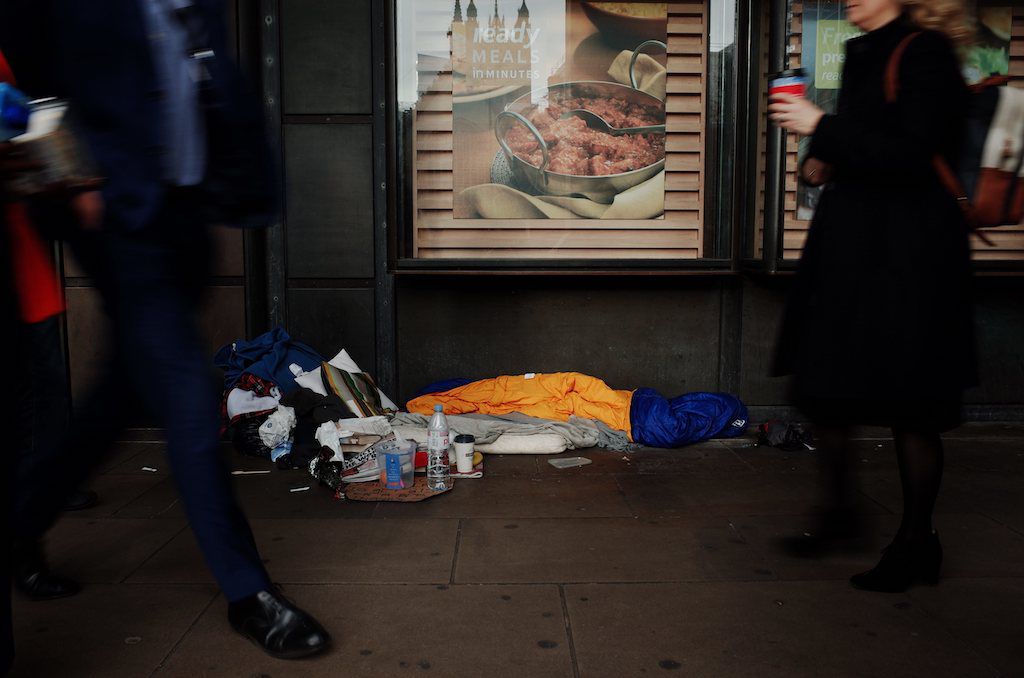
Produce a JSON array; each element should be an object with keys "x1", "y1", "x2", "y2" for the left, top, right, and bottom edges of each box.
[{"x1": 128, "y1": 519, "x2": 459, "y2": 584}]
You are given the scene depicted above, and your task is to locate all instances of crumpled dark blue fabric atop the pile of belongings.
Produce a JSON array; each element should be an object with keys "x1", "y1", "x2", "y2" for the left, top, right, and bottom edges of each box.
[{"x1": 213, "y1": 327, "x2": 325, "y2": 393}]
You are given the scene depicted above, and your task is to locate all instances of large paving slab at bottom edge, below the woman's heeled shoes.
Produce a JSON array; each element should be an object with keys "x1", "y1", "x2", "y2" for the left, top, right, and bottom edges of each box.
[{"x1": 565, "y1": 582, "x2": 997, "y2": 678}]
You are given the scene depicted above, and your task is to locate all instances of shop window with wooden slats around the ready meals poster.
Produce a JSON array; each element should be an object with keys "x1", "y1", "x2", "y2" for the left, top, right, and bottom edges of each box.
[{"x1": 394, "y1": 0, "x2": 736, "y2": 267}]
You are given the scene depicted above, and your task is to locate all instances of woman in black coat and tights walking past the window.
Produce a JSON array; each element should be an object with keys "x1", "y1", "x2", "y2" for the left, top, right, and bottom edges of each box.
[{"x1": 769, "y1": 0, "x2": 976, "y2": 591}]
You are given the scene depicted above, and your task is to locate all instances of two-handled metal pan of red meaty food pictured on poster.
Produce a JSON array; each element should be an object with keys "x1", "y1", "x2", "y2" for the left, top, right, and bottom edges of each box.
[{"x1": 495, "y1": 41, "x2": 665, "y2": 203}]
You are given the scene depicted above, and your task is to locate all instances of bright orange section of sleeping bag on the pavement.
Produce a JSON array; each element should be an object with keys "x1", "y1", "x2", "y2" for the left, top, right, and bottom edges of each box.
[{"x1": 408, "y1": 372, "x2": 633, "y2": 439}]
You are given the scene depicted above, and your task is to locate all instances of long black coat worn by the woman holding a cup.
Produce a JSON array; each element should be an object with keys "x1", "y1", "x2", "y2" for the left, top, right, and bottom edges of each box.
[{"x1": 776, "y1": 18, "x2": 976, "y2": 430}]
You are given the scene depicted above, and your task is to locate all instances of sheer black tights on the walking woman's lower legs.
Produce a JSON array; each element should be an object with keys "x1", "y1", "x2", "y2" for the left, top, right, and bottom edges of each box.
[{"x1": 817, "y1": 426, "x2": 943, "y2": 540}]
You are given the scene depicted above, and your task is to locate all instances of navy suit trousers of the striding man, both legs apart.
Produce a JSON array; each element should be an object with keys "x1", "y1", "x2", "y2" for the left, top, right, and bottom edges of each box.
[{"x1": 16, "y1": 190, "x2": 269, "y2": 601}]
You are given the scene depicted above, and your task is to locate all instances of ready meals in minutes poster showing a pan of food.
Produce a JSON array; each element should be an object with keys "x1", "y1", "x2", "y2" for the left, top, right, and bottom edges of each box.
[{"x1": 447, "y1": 0, "x2": 668, "y2": 219}]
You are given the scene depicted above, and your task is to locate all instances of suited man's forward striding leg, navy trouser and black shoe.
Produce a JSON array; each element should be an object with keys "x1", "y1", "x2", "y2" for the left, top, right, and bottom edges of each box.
[{"x1": 99, "y1": 201, "x2": 329, "y2": 658}]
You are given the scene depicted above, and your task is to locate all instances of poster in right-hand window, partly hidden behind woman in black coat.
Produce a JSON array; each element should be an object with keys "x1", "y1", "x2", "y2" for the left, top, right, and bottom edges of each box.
[{"x1": 797, "y1": 0, "x2": 1013, "y2": 220}]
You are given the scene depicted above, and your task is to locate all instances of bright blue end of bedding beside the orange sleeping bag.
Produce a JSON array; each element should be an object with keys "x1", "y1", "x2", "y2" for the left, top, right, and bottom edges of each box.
[{"x1": 630, "y1": 388, "x2": 748, "y2": 448}]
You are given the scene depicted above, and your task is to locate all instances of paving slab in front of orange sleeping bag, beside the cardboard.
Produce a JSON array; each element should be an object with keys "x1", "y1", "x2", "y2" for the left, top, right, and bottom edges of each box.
[{"x1": 374, "y1": 475, "x2": 633, "y2": 518}]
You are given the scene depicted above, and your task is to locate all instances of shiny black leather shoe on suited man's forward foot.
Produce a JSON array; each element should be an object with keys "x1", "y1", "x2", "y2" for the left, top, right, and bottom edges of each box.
[{"x1": 227, "y1": 591, "x2": 331, "y2": 660}]
